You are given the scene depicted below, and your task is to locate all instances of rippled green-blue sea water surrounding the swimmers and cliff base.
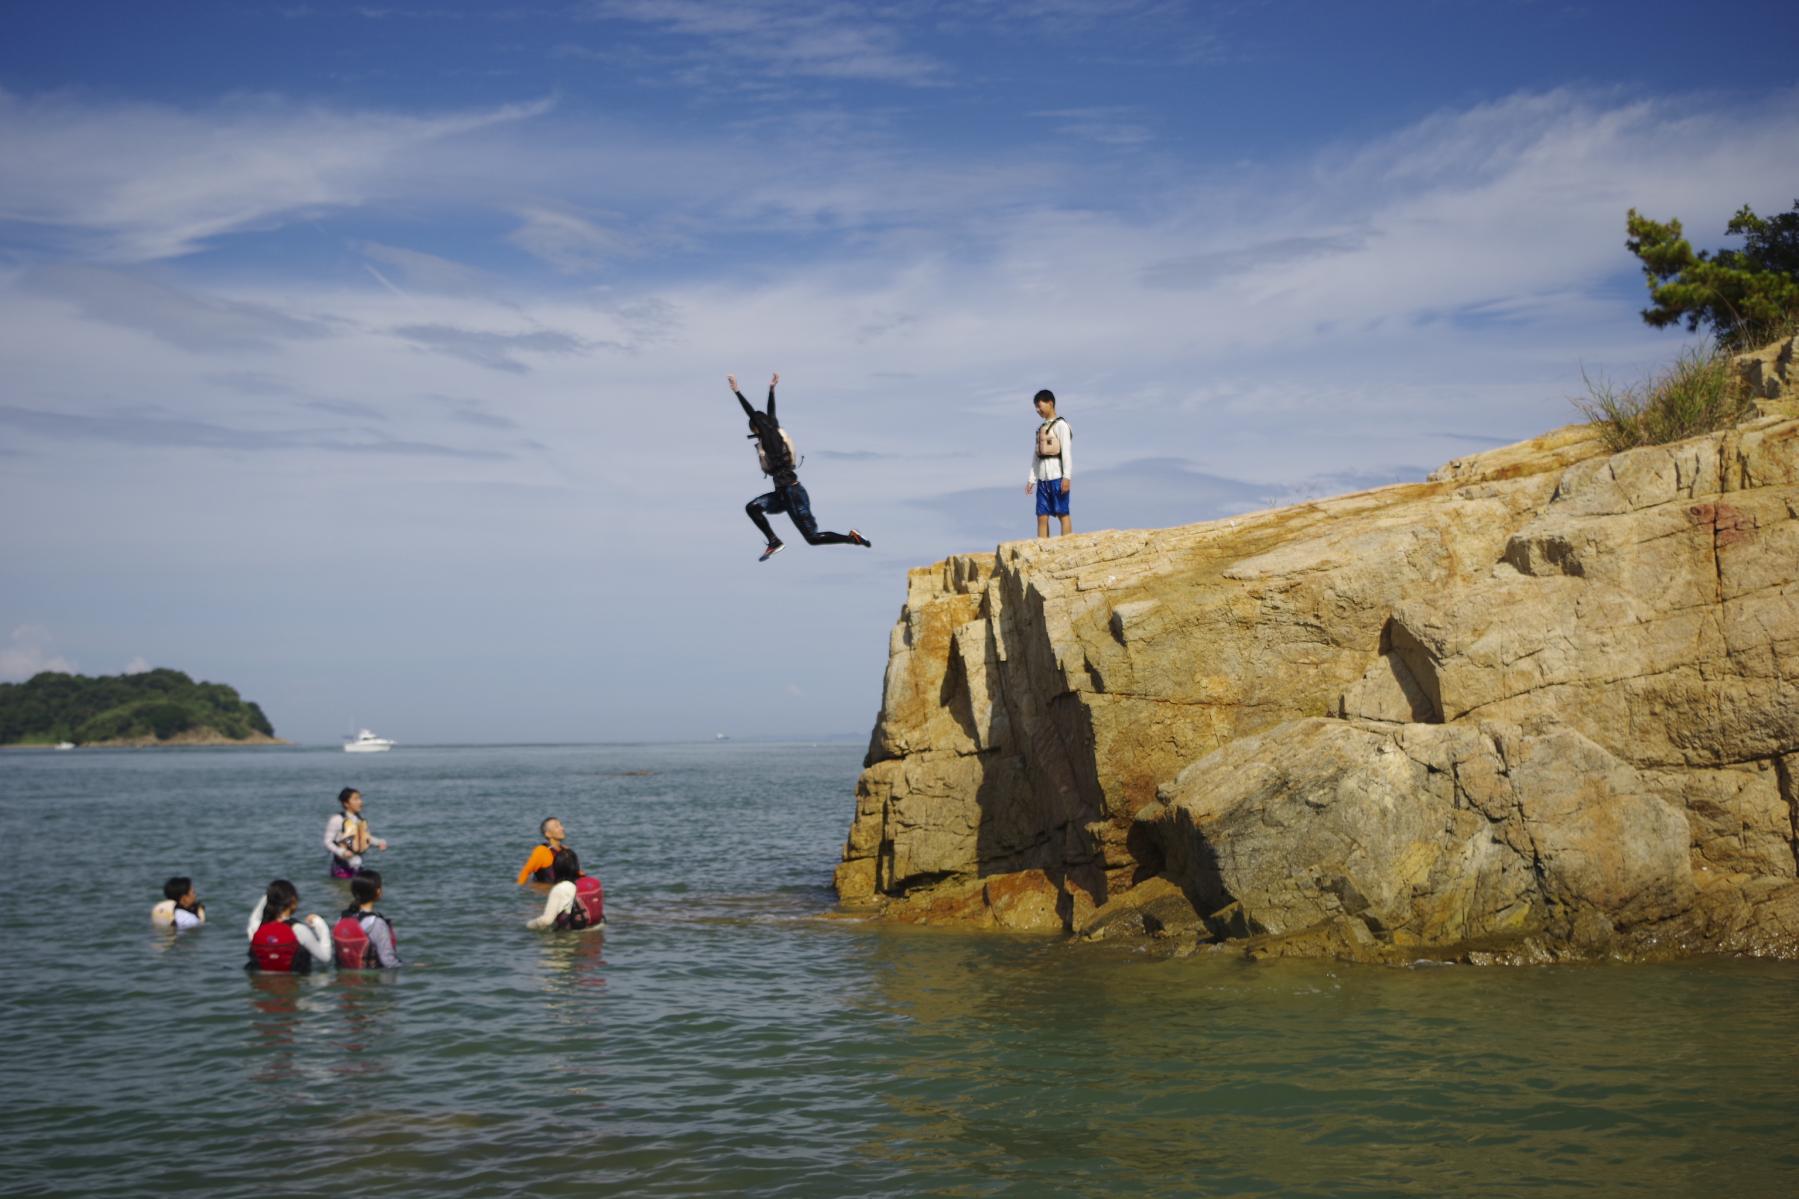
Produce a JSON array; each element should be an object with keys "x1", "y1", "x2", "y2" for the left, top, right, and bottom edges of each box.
[{"x1": 0, "y1": 744, "x2": 1799, "y2": 1199}]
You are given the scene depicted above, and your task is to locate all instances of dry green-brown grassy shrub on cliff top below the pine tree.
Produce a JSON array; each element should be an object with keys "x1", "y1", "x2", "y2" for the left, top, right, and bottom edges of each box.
[{"x1": 1574, "y1": 347, "x2": 1749, "y2": 454}]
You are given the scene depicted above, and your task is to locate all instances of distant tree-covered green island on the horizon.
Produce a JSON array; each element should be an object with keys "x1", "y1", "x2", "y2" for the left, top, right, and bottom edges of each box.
[{"x1": 0, "y1": 668, "x2": 286, "y2": 747}]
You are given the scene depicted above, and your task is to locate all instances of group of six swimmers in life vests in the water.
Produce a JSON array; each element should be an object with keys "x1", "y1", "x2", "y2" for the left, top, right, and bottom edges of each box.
[{"x1": 149, "y1": 787, "x2": 606, "y2": 974}]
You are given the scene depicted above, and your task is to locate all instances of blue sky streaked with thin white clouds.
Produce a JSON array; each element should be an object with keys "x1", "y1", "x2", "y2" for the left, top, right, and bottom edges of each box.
[{"x1": 0, "y1": 0, "x2": 1799, "y2": 742}]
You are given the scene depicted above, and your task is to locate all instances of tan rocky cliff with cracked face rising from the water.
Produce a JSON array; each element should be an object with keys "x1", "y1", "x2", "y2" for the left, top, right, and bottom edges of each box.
[{"x1": 837, "y1": 342, "x2": 1799, "y2": 961}]
